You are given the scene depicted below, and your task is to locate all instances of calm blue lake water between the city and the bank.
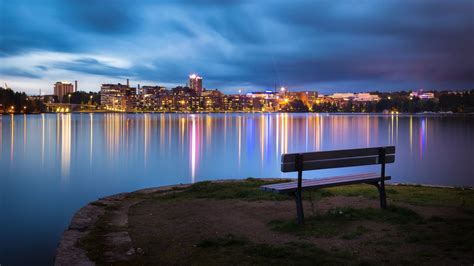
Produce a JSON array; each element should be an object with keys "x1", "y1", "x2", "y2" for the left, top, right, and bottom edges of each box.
[{"x1": 0, "y1": 114, "x2": 474, "y2": 265}]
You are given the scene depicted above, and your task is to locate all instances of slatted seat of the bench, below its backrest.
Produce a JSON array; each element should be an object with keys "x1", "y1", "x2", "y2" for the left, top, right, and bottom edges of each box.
[{"x1": 260, "y1": 173, "x2": 391, "y2": 194}]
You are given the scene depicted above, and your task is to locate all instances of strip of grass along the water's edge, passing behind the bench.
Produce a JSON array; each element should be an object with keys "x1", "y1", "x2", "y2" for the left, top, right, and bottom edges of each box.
[{"x1": 132, "y1": 178, "x2": 474, "y2": 211}]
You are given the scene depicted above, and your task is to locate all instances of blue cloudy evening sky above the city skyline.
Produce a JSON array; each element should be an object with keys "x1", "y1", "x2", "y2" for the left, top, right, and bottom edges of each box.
[{"x1": 0, "y1": 0, "x2": 474, "y2": 94}]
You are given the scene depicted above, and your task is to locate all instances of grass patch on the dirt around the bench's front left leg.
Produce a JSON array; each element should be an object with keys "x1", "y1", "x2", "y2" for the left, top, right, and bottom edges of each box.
[{"x1": 268, "y1": 205, "x2": 422, "y2": 239}]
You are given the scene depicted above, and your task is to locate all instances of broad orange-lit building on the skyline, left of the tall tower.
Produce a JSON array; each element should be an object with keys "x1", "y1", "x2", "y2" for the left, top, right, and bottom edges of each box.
[{"x1": 100, "y1": 83, "x2": 137, "y2": 111}]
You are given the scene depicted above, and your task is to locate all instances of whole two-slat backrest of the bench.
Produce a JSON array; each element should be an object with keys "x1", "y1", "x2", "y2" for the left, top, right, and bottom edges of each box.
[{"x1": 281, "y1": 146, "x2": 395, "y2": 172}]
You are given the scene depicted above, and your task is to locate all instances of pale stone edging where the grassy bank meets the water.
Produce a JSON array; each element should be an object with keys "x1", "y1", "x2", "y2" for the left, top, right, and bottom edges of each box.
[{"x1": 54, "y1": 178, "x2": 474, "y2": 265}]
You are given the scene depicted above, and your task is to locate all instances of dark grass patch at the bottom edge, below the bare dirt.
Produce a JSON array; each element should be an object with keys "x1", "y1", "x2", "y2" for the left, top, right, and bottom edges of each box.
[{"x1": 192, "y1": 234, "x2": 356, "y2": 265}]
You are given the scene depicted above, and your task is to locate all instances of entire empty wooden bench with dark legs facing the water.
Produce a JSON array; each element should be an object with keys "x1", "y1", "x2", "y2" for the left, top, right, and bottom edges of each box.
[{"x1": 260, "y1": 146, "x2": 395, "y2": 224}]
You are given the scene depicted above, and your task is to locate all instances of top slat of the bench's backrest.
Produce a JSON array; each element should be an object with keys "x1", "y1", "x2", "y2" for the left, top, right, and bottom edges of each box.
[{"x1": 281, "y1": 146, "x2": 395, "y2": 163}]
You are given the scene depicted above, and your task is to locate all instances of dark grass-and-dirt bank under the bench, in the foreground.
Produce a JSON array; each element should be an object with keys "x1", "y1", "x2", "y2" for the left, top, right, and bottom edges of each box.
[{"x1": 80, "y1": 179, "x2": 474, "y2": 265}]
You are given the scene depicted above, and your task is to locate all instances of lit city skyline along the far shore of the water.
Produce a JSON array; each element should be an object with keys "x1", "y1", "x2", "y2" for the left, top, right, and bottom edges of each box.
[{"x1": 3, "y1": 74, "x2": 462, "y2": 114}]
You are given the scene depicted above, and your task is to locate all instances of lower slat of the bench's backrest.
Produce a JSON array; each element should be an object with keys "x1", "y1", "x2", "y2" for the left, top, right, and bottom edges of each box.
[{"x1": 281, "y1": 155, "x2": 395, "y2": 173}]
